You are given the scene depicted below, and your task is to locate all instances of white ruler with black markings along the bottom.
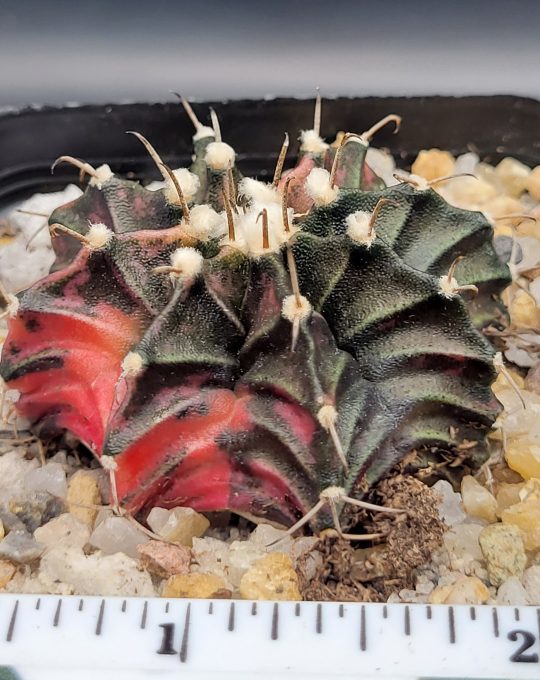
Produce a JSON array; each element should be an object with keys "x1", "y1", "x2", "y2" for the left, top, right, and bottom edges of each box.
[{"x1": 0, "y1": 595, "x2": 540, "y2": 680}]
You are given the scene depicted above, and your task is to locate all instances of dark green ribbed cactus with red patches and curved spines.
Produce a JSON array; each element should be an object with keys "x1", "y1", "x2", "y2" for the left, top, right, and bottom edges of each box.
[{"x1": 0, "y1": 104, "x2": 509, "y2": 531}]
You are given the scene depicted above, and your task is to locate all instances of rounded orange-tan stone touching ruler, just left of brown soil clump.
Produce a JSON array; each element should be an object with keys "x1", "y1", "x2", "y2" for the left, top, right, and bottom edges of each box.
[{"x1": 240, "y1": 552, "x2": 302, "y2": 600}]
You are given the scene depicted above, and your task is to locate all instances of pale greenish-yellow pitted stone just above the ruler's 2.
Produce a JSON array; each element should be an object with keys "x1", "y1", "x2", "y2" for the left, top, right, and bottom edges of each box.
[{"x1": 479, "y1": 524, "x2": 527, "y2": 586}]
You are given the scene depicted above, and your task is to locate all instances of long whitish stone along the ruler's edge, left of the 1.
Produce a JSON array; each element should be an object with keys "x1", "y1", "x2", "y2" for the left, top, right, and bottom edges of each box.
[{"x1": 40, "y1": 547, "x2": 155, "y2": 597}]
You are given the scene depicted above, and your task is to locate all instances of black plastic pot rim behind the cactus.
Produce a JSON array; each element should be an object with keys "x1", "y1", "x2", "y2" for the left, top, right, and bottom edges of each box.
[{"x1": 0, "y1": 96, "x2": 540, "y2": 207}]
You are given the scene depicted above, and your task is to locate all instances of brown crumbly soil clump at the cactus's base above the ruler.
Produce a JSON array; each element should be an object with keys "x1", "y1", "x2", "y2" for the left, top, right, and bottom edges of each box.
[{"x1": 299, "y1": 474, "x2": 445, "y2": 602}]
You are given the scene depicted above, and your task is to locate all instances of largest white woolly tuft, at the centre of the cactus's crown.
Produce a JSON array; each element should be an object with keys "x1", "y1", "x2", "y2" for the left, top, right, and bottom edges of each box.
[{"x1": 234, "y1": 203, "x2": 296, "y2": 257}]
